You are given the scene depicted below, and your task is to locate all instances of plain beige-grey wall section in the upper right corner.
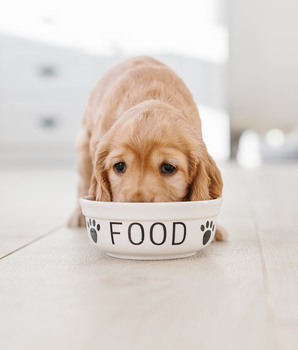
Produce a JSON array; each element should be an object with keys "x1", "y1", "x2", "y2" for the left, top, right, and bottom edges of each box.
[{"x1": 228, "y1": 0, "x2": 298, "y2": 132}]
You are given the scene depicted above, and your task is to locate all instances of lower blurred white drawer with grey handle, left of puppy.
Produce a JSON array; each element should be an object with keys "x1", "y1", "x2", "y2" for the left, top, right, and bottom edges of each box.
[{"x1": 0, "y1": 103, "x2": 85, "y2": 147}]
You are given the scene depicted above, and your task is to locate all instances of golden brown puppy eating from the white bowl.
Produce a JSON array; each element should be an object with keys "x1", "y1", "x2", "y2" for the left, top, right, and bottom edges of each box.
[{"x1": 69, "y1": 57, "x2": 226, "y2": 240}]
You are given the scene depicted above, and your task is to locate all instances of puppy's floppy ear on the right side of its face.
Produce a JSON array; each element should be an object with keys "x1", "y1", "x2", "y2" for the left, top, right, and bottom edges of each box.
[{"x1": 187, "y1": 143, "x2": 223, "y2": 201}]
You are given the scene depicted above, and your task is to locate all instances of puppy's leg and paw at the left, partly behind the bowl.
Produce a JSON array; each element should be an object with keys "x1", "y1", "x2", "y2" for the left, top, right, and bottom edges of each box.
[{"x1": 67, "y1": 127, "x2": 92, "y2": 227}]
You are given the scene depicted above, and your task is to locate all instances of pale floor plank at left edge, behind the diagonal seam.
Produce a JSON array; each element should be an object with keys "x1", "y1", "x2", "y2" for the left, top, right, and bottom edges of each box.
[{"x1": 0, "y1": 168, "x2": 77, "y2": 241}]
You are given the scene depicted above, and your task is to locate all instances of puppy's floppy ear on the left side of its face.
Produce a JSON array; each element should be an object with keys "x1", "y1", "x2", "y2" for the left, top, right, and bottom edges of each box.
[{"x1": 89, "y1": 139, "x2": 112, "y2": 202}]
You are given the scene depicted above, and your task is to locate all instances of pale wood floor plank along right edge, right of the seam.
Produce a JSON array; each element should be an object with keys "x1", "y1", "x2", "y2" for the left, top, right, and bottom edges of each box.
[{"x1": 252, "y1": 164, "x2": 298, "y2": 324}]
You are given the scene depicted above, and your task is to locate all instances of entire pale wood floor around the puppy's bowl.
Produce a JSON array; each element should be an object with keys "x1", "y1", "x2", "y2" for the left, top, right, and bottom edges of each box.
[{"x1": 0, "y1": 163, "x2": 298, "y2": 350}]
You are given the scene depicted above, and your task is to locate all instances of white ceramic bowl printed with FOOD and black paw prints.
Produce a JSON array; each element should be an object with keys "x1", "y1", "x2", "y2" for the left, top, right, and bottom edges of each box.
[{"x1": 80, "y1": 196, "x2": 223, "y2": 260}]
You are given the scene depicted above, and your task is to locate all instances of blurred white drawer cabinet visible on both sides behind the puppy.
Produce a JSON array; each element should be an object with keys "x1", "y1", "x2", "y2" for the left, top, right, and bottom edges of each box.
[{"x1": 0, "y1": 33, "x2": 229, "y2": 161}]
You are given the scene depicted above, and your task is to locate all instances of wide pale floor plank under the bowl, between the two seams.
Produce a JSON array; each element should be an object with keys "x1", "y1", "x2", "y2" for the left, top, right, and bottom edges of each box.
[{"x1": 0, "y1": 217, "x2": 278, "y2": 350}]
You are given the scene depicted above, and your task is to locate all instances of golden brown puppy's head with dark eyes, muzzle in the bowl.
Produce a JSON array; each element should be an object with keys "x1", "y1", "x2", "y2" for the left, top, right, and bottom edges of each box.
[{"x1": 90, "y1": 101, "x2": 222, "y2": 202}]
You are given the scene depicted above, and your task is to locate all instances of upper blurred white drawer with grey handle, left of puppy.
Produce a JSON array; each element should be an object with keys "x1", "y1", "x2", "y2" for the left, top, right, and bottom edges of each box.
[{"x1": 0, "y1": 51, "x2": 94, "y2": 90}]
